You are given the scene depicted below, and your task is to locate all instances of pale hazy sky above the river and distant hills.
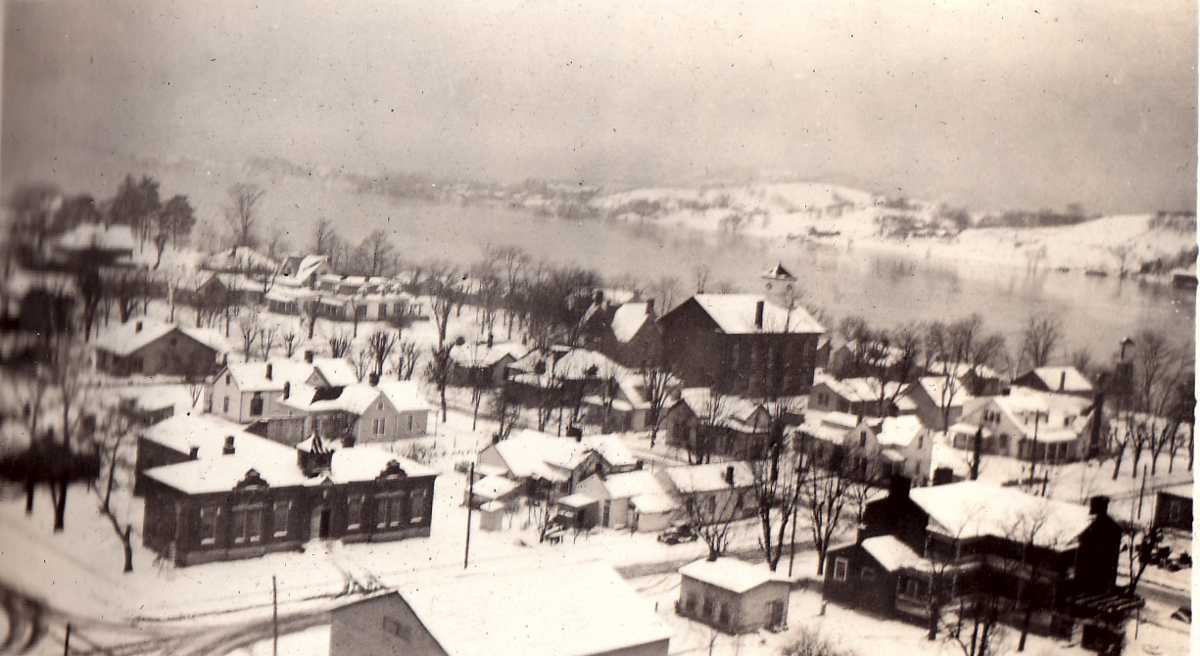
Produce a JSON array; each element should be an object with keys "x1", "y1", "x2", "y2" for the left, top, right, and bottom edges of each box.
[{"x1": 0, "y1": 0, "x2": 1198, "y2": 212}]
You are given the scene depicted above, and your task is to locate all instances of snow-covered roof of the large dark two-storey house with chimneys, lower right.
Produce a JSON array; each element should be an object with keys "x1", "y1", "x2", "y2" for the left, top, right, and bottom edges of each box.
[{"x1": 910, "y1": 481, "x2": 1092, "y2": 549}]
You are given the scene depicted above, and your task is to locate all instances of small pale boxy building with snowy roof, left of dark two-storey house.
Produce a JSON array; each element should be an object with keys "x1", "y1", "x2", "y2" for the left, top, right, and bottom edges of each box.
[{"x1": 676, "y1": 558, "x2": 792, "y2": 634}]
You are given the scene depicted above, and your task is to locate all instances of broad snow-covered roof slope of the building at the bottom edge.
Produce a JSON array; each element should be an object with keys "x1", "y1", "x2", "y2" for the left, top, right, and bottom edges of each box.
[{"x1": 396, "y1": 561, "x2": 671, "y2": 656}]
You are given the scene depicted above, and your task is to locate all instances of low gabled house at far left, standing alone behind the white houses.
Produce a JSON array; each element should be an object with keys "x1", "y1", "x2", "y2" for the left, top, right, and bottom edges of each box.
[{"x1": 94, "y1": 317, "x2": 228, "y2": 379}]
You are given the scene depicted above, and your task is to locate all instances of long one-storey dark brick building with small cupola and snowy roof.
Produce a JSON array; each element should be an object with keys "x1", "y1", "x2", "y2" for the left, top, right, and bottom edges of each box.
[{"x1": 137, "y1": 416, "x2": 437, "y2": 566}]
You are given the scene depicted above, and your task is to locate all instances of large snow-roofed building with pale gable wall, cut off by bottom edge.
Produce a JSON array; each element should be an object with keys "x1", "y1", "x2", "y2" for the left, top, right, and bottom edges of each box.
[{"x1": 329, "y1": 562, "x2": 671, "y2": 656}]
